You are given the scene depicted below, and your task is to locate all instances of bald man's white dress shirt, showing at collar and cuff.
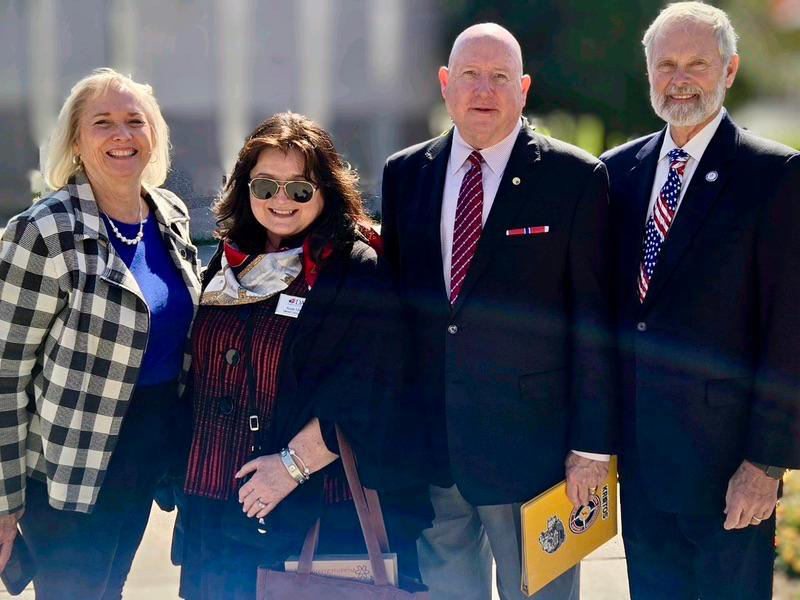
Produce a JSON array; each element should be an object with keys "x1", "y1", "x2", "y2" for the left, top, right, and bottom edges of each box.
[{"x1": 439, "y1": 119, "x2": 608, "y2": 461}]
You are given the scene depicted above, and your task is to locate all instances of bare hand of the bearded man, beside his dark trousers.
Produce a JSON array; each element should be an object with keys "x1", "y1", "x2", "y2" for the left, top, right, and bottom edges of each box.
[{"x1": 724, "y1": 460, "x2": 778, "y2": 529}]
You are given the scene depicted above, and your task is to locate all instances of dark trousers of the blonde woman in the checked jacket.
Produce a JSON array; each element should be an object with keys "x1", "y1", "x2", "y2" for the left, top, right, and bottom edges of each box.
[{"x1": 20, "y1": 383, "x2": 176, "y2": 600}]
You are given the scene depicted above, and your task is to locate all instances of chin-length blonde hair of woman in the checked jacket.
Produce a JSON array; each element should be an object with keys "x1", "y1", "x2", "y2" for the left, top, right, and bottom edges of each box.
[{"x1": 44, "y1": 67, "x2": 170, "y2": 190}]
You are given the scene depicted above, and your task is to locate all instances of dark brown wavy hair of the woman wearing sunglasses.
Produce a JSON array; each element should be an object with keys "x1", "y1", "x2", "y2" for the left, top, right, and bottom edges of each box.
[{"x1": 214, "y1": 112, "x2": 371, "y2": 262}]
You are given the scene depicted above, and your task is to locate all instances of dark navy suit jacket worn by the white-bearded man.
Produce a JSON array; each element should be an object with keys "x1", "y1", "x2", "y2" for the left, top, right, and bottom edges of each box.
[{"x1": 601, "y1": 116, "x2": 800, "y2": 514}]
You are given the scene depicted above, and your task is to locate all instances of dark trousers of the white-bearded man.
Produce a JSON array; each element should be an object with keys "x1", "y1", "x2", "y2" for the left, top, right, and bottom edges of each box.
[{"x1": 621, "y1": 468, "x2": 775, "y2": 600}]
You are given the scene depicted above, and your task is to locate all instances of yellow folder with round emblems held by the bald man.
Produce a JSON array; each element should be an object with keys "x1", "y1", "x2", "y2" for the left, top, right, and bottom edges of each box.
[{"x1": 520, "y1": 456, "x2": 617, "y2": 596}]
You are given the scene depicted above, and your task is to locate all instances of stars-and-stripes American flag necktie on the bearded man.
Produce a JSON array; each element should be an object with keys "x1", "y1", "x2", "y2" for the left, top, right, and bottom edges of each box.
[{"x1": 637, "y1": 148, "x2": 690, "y2": 302}]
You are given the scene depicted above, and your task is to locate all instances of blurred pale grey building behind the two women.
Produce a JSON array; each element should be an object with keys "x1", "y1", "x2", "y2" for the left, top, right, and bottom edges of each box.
[{"x1": 0, "y1": 0, "x2": 443, "y2": 238}]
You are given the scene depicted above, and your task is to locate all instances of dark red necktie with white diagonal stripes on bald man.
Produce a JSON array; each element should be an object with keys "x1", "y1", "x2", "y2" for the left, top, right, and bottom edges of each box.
[{"x1": 450, "y1": 150, "x2": 483, "y2": 306}]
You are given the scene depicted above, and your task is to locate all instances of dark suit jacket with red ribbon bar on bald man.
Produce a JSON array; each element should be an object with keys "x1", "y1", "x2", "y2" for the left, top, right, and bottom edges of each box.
[{"x1": 382, "y1": 126, "x2": 616, "y2": 505}]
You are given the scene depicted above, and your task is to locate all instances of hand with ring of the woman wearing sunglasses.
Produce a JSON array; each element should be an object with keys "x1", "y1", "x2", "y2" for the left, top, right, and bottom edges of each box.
[{"x1": 236, "y1": 454, "x2": 298, "y2": 519}]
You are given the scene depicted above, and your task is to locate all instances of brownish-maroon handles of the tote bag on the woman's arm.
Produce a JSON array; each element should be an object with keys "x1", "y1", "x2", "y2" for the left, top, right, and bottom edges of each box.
[{"x1": 297, "y1": 425, "x2": 389, "y2": 586}]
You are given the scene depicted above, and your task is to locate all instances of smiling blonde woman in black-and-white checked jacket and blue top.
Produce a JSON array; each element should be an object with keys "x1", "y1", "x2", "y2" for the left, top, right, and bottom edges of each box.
[{"x1": 0, "y1": 69, "x2": 200, "y2": 600}]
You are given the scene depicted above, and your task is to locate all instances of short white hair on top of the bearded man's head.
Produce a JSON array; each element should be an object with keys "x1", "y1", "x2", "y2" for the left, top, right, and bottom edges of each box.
[{"x1": 642, "y1": 2, "x2": 737, "y2": 65}]
